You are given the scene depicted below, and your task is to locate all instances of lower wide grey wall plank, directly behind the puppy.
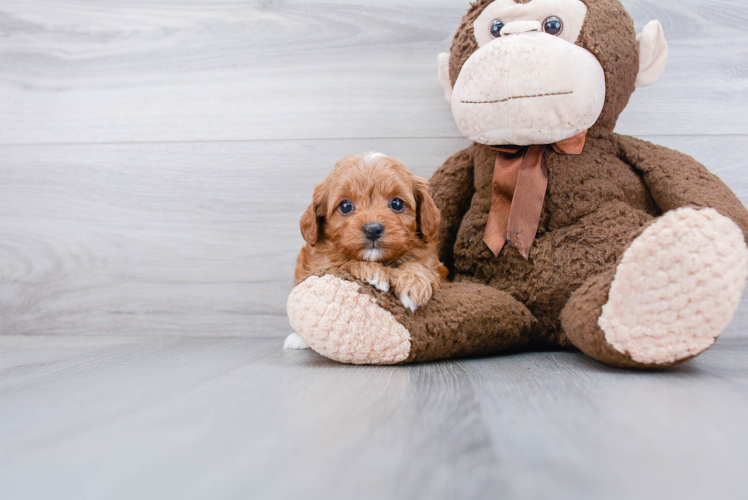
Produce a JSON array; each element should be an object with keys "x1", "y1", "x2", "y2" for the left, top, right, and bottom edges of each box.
[{"x1": 0, "y1": 136, "x2": 748, "y2": 336}]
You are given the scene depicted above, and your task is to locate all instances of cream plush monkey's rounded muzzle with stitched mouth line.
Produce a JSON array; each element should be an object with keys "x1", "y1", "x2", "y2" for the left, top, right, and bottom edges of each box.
[{"x1": 452, "y1": 33, "x2": 605, "y2": 146}]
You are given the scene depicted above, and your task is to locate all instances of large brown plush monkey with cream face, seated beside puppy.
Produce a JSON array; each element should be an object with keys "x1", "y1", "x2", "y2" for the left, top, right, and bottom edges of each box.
[{"x1": 288, "y1": 0, "x2": 748, "y2": 368}]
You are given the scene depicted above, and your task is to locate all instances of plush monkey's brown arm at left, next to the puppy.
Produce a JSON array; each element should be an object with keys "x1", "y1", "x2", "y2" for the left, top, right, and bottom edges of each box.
[{"x1": 429, "y1": 148, "x2": 475, "y2": 271}]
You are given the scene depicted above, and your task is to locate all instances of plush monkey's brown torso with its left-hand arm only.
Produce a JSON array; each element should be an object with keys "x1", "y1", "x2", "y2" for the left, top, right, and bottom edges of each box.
[{"x1": 438, "y1": 137, "x2": 660, "y2": 345}]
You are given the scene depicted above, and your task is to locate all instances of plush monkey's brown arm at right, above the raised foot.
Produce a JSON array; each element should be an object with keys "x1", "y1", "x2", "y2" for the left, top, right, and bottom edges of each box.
[{"x1": 615, "y1": 134, "x2": 748, "y2": 241}]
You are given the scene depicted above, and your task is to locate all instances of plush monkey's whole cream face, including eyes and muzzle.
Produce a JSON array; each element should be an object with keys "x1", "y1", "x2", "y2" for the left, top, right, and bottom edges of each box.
[{"x1": 451, "y1": 0, "x2": 605, "y2": 146}]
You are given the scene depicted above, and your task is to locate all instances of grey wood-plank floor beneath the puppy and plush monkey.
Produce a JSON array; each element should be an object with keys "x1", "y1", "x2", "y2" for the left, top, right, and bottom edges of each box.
[{"x1": 0, "y1": 336, "x2": 748, "y2": 500}]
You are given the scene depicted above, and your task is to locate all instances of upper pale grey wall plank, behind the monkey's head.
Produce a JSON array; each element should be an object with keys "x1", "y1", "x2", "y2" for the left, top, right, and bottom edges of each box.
[{"x1": 0, "y1": 0, "x2": 748, "y2": 144}]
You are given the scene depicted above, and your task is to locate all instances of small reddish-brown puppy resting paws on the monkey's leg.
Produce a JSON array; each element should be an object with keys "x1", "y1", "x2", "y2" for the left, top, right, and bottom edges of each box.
[{"x1": 295, "y1": 153, "x2": 447, "y2": 311}]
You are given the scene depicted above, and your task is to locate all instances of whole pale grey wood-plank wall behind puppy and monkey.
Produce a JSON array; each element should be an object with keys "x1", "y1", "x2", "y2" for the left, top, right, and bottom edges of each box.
[{"x1": 0, "y1": 0, "x2": 748, "y2": 336}]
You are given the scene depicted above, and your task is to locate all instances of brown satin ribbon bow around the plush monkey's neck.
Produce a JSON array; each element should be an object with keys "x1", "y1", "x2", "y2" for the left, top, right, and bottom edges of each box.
[{"x1": 483, "y1": 131, "x2": 587, "y2": 259}]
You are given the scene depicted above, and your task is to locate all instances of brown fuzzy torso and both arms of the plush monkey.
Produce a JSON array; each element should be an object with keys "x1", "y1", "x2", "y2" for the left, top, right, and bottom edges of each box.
[{"x1": 431, "y1": 133, "x2": 748, "y2": 364}]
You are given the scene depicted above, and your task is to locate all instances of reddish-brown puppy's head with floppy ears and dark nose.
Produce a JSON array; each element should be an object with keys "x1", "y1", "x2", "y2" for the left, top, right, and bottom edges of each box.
[{"x1": 301, "y1": 153, "x2": 439, "y2": 262}]
